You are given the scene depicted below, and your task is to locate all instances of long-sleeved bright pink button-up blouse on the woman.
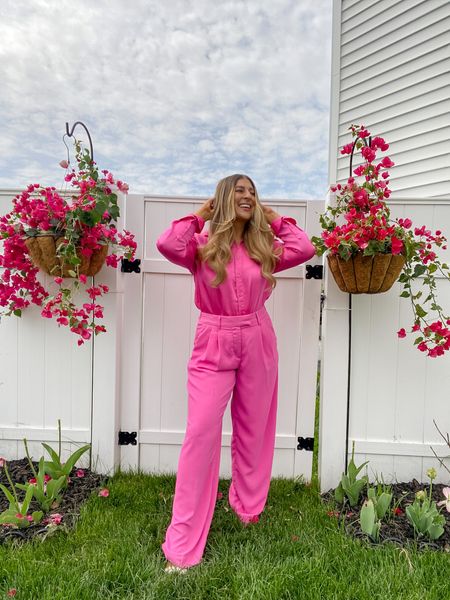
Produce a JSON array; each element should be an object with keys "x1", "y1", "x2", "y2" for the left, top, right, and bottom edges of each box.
[{"x1": 156, "y1": 214, "x2": 315, "y2": 316}]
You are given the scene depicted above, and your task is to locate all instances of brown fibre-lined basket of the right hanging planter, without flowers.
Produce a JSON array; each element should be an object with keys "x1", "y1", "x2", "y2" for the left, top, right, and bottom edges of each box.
[{"x1": 327, "y1": 253, "x2": 405, "y2": 294}]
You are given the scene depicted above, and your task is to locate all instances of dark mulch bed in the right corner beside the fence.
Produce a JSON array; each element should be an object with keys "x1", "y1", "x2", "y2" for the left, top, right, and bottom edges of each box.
[{"x1": 322, "y1": 479, "x2": 450, "y2": 552}]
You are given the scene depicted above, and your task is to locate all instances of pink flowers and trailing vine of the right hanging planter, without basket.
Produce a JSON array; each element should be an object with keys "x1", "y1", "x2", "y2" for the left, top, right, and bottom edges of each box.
[{"x1": 312, "y1": 125, "x2": 450, "y2": 357}]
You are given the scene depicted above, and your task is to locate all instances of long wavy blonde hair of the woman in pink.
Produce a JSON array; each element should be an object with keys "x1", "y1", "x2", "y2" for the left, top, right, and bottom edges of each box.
[{"x1": 198, "y1": 173, "x2": 281, "y2": 289}]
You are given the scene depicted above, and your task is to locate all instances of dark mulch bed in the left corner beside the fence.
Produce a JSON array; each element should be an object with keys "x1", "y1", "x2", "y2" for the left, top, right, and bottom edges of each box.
[{"x1": 0, "y1": 458, "x2": 108, "y2": 543}]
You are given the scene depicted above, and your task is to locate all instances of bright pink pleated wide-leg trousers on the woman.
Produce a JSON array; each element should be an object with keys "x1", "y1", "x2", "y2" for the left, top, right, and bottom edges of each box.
[{"x1": 162, "y1": 308, "x2": 278, "y2": 567}]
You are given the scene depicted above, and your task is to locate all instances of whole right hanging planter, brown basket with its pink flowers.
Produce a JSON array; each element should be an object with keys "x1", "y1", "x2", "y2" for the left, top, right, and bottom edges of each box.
[{"x1": 311, "y1": 124, "x2": 450, "y2": 357}]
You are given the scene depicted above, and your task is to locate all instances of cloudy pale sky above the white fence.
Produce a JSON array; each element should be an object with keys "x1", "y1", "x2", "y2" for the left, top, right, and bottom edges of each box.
[{"x1": 0, "y1": 0, "x2": 332, "y2": 199}]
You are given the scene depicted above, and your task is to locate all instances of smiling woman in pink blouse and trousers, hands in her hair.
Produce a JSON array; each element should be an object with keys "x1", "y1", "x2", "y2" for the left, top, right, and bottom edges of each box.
[{"x1": 157, "y1": 174, "x2": 315, "y2": 572}]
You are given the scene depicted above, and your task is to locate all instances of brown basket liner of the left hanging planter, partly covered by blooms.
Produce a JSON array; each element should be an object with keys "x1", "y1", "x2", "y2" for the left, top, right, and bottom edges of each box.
[{"x1": 25, "y1": 235, "x2": 108, "y2": 277}]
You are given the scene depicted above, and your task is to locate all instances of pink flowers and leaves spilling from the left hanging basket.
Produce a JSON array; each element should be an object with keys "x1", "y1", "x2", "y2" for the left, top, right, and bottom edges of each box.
[{"x1": 0, "y1": 148, "x2": 136, "y2": 345}]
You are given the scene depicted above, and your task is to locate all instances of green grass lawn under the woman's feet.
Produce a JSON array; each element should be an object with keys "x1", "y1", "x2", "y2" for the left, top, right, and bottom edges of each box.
[{"x1": 0, "y1": 384, "x2": 450, "y2": 600}]
